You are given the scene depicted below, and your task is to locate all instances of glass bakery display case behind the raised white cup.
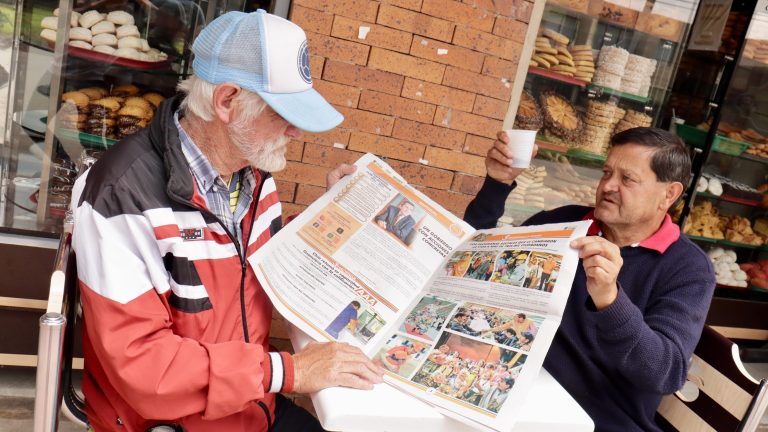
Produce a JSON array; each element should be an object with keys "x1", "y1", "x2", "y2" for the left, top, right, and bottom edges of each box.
[{"x1": 502, "y1": 0, "x2": 698, "y2": 225}]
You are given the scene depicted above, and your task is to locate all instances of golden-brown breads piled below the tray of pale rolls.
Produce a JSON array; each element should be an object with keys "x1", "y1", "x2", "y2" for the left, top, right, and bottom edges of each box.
[{"x1": 60, "y1": 84, "x2": 165, "y2": 139}]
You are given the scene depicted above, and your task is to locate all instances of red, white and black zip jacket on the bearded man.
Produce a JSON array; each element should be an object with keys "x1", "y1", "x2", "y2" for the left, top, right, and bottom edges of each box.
[{"x1": 73, "y1": 98, "x2": 293, "y2": 432}]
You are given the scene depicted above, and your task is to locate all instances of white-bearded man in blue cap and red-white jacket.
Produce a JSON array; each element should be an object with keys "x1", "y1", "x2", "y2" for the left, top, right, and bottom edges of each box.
[{"x1": 73, "y1": 11, "x2": 383, "y2": 431}]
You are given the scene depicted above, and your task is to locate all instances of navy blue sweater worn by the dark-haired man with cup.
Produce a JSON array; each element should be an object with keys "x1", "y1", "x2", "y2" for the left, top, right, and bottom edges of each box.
[{"x1": 464, "y1": 178, "x2": 715, "y2": 432}]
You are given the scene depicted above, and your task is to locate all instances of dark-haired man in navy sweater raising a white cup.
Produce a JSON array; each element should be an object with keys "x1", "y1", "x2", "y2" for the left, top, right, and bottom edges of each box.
[{"x1": 464, "y1": 128, "x2": 715, "y2": 431}]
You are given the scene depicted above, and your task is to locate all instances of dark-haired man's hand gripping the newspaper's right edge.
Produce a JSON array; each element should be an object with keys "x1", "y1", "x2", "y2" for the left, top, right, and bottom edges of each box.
[{"x1": 571, "y1": 236, "x2": 624, "y2": 310}]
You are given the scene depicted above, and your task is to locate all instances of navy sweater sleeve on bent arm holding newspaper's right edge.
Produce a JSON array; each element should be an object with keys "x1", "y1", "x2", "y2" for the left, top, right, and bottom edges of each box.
[{"x1": 592, "y1": 257, "x2": 715, "y2": 394}]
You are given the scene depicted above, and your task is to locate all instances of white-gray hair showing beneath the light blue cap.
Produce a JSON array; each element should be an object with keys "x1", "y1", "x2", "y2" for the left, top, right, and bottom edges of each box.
[{"x1": 177, "y1": 75, "x2": 267, "y2": 123}]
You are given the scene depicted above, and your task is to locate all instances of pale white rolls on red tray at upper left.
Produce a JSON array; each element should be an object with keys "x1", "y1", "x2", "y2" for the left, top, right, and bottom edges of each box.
[{"x1": 40, "y1": 9, "x2": 168, "y2": 62}]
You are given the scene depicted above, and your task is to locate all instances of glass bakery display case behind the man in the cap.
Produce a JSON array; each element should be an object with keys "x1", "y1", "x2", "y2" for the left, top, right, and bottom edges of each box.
[{"x1": 0, "y1": 0, "x2": 288, "y2": 236}]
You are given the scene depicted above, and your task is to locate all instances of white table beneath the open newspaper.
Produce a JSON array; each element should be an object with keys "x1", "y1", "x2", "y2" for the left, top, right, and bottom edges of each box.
[{"x1": 289, "y1": 325, "x2": 595, "y2": 432}]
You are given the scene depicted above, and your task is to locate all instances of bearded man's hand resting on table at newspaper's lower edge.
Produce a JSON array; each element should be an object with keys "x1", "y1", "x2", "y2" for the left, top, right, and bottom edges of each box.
[{"x1": 293, "y1": 342, "x2": 384, "y2": 393}]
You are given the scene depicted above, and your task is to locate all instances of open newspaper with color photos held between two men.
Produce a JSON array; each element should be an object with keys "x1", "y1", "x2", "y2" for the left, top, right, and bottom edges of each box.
[{"x1": 249, "y1": 154, "x2": 590, "y2": 431}]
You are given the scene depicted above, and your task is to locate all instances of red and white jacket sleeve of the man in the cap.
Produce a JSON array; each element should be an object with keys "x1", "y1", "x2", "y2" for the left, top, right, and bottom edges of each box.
[{"x1": 73, "y1": 184, "x2": 293, "y2": 419}]
